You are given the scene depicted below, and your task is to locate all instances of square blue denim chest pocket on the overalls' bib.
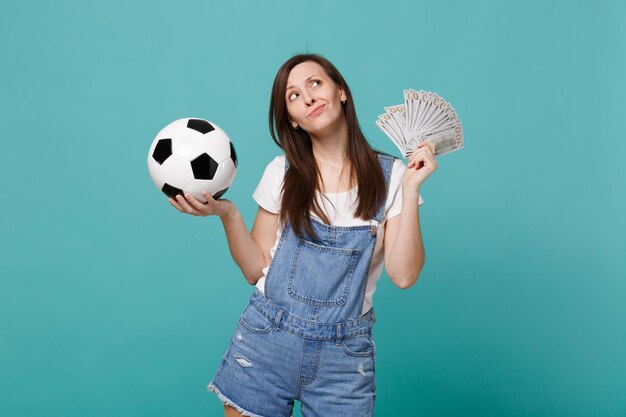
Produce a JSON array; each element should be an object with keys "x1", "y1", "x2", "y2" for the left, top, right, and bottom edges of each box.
[{"x1": 287, "y1": 239, "x2": 360, "y2": 307}]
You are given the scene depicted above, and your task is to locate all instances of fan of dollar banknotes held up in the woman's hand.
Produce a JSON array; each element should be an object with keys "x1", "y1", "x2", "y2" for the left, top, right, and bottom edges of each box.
[{"x1": 376, "y1": 90, "x2": 463, "y2": 158}]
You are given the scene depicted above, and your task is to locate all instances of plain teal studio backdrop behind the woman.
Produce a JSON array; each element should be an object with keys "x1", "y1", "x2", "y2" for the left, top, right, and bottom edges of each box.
[{"x1": 0, "y1": 0, "x2": 626, "y2": 417}]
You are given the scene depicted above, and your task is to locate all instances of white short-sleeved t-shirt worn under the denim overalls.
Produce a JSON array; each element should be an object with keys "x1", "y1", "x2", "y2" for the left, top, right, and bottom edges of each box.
[{"x1": 252, "y1": 155, "x2": 424, "y2": 314}]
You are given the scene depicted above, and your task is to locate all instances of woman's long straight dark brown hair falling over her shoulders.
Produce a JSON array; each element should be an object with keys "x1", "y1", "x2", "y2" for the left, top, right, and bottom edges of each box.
[{"x1": 269, "y1": 54, "x2": 387, "y2": 237}]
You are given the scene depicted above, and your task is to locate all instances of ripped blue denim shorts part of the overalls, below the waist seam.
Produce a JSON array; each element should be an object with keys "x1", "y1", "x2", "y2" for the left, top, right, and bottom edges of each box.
[{"x1": 208, "y1": 290, "x2": 376, "y2": 417}]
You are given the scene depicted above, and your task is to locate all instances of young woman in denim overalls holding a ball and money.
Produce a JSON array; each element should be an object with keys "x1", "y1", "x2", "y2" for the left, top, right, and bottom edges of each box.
[{"x1": 169, "y1": 54, "x2": 437, "y2": 417}]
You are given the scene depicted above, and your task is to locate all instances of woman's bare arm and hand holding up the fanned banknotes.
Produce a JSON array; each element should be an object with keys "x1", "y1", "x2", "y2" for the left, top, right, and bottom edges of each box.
[{"x1": 384, "y1": 141, "x2": 437, "y2": 288}]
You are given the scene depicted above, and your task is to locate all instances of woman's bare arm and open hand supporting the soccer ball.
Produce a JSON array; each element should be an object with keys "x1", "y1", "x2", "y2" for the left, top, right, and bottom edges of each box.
[{"x1": 168, "y1": 193, "x2": 278, "y2": 285}]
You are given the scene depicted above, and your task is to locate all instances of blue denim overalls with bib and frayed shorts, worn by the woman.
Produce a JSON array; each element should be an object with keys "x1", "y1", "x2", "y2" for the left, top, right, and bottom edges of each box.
[{"x1": 208, "y1": 154, "x2": 393, "y2": 417}]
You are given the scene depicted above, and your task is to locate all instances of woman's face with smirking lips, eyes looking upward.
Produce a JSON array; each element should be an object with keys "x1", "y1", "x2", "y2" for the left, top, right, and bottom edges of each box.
[{"x1": 285, "y1": 61, "x2": 346, "y2": 134}]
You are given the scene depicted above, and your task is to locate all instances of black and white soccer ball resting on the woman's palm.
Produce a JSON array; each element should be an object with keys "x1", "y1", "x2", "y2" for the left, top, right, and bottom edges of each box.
[{"x1": 148, "y1": 118, "x2": 237, "y2": 203}]
